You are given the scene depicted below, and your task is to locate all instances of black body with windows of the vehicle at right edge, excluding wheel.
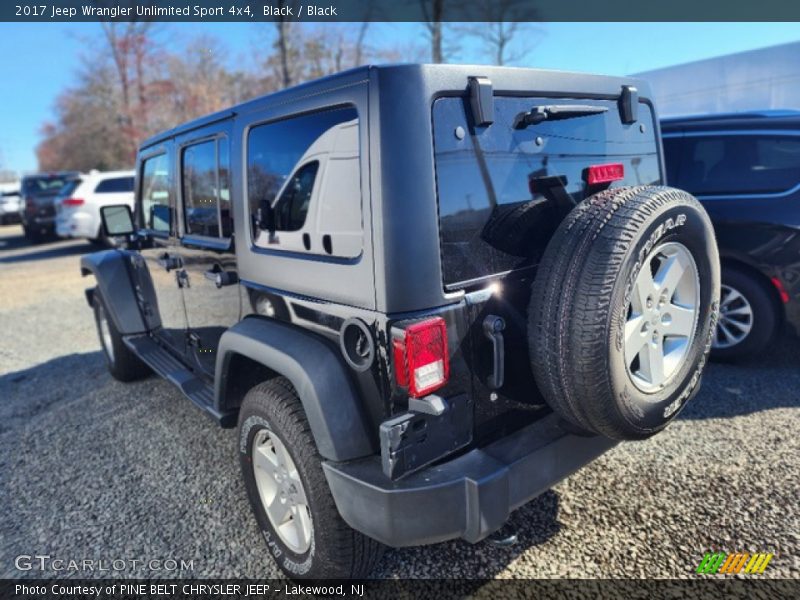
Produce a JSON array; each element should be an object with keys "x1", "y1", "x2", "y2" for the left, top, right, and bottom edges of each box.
[{"x1": 661, "y1": 111, "x2": 800, "y2": 332}]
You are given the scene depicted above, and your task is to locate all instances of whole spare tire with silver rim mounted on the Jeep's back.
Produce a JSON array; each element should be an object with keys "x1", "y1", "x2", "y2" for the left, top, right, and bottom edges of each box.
[{"x1": 528, "y1": 186, "x2": 720, "y2": 440}]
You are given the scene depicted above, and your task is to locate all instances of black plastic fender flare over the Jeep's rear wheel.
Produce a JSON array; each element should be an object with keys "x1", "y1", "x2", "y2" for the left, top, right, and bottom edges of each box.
[{"x1": 214, "y1": 317, "x2": 374, "y2": 461}]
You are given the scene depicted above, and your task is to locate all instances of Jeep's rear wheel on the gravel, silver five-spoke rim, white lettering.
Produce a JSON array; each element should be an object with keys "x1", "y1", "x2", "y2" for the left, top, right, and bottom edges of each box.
[{"x1": 239, "y1": 377, "x2": 384, "y2": 579}]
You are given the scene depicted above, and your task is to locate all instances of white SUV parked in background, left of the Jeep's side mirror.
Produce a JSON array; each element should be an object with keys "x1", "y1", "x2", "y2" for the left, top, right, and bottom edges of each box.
[{"x1": 55, "y1": 170, "x2": 135, "y2": 245}]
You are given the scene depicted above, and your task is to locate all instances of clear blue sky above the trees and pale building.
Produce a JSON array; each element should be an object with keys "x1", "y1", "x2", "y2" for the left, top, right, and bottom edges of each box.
[{"x1": 0, "y1": 23, "x2": 800, "y2": 172}]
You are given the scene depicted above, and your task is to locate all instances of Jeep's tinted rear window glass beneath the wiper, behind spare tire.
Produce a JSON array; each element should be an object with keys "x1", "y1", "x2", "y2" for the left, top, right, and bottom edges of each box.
[{"x1": 433, "y1": 98, "x2": 662, "y2": 289}]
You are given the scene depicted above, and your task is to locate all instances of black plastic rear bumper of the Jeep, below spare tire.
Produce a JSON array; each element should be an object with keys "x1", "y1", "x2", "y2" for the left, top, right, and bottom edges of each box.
[{"x1": 323, "y1": 415, "x2": 616, "y2": 547}]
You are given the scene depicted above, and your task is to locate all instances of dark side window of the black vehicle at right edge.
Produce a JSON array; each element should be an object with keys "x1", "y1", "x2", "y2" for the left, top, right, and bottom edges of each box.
[{"x1": 664, "y1": 133, "x2": 800, "y2": 195}]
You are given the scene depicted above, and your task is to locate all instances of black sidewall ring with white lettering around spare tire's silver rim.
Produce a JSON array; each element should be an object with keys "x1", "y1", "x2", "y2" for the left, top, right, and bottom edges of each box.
[{"x1": 608, "y1": 196, "x2": 720, "y2": 436}]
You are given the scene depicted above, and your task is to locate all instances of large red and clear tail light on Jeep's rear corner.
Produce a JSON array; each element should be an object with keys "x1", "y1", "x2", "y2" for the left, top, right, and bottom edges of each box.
[{"x1": 392, "y1": 317, "x2": 450, "y2": 398}]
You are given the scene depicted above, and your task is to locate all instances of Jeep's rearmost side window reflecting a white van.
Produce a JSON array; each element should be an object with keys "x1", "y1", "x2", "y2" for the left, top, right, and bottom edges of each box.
[{"x1": 247, "y1": 107, "x2": 363, "y2": 257}]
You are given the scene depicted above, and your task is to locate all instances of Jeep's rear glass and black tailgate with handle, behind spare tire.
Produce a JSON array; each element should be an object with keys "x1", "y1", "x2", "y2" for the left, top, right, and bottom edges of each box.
[{"x1": 433, "y1": 96, "x2": 662, "y2": 438}]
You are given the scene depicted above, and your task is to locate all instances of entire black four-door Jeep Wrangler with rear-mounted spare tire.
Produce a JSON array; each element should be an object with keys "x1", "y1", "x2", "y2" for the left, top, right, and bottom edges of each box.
[{"x1": 81, "y1": 65, "x2": 720, "y2": 578}]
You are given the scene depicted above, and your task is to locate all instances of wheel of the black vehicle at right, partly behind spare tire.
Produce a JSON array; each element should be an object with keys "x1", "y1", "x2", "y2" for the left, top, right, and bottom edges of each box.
[{"x1": 711, "y1": 267, "x2": 778, "y2": 360}]
